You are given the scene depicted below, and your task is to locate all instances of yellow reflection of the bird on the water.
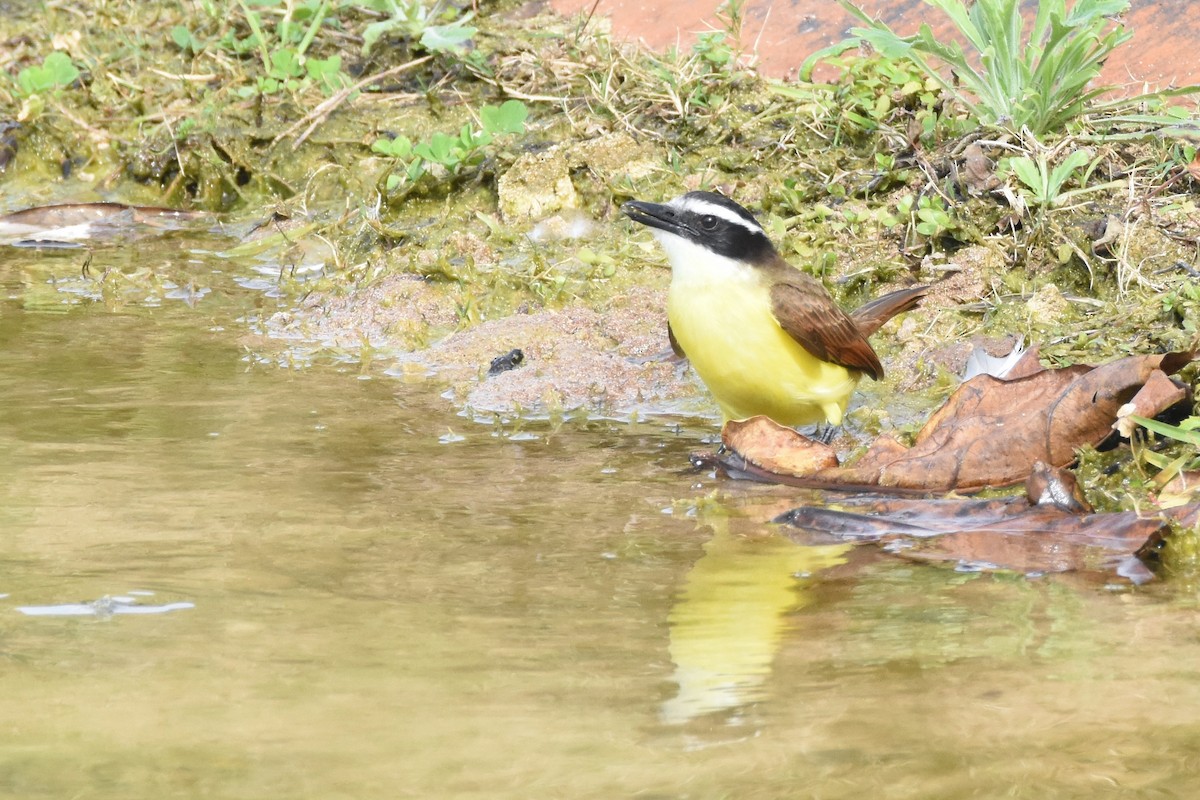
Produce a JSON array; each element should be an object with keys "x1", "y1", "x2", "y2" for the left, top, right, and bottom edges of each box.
[{"x1": 662, "y1": 517, "x2": 853, "y2": 724}]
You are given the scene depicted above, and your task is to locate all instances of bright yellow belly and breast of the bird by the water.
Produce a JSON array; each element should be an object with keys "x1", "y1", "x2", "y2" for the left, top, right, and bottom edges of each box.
[{"x1": 667, "y1": 282, "x2": 859, "y2": 426}]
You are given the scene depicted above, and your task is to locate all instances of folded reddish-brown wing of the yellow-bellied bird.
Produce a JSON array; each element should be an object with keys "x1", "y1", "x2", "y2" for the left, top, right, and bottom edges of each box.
[{"x1": 770, "y1": 272, "x2": 883, "y2": 380}]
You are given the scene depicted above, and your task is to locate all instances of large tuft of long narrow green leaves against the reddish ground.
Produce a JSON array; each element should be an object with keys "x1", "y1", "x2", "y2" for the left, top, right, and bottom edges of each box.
[{"x1": 810, "y1": 0, "x2": 1132, "y2": 136}]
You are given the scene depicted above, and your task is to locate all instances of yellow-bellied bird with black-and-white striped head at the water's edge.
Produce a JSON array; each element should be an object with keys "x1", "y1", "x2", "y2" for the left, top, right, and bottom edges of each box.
[{"x1": 622, "y1": 192, "x2": 926, "y2": 426}]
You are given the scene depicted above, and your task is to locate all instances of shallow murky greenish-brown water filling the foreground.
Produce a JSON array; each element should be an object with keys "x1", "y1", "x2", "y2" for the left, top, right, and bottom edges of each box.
[{"x1": 0, "y1": 237, "x2": 1200, "y2": 800}]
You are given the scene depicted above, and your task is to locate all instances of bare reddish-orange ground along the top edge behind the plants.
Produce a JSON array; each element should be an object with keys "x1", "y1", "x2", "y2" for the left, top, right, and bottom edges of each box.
[{"x1": 551, "y1": 0, "x2": 1200, "y2": 92}]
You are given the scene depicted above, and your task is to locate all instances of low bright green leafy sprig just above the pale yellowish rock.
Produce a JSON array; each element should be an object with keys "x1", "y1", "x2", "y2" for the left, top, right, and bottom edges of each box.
[{"x1": 371, "y1": 100, "x2": 529, "y2": 194}]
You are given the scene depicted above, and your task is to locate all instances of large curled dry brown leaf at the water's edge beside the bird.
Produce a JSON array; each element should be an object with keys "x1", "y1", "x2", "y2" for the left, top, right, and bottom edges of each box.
[{"x1": 721, "y1": 353, "x2": 1193, "y2": 493}]
